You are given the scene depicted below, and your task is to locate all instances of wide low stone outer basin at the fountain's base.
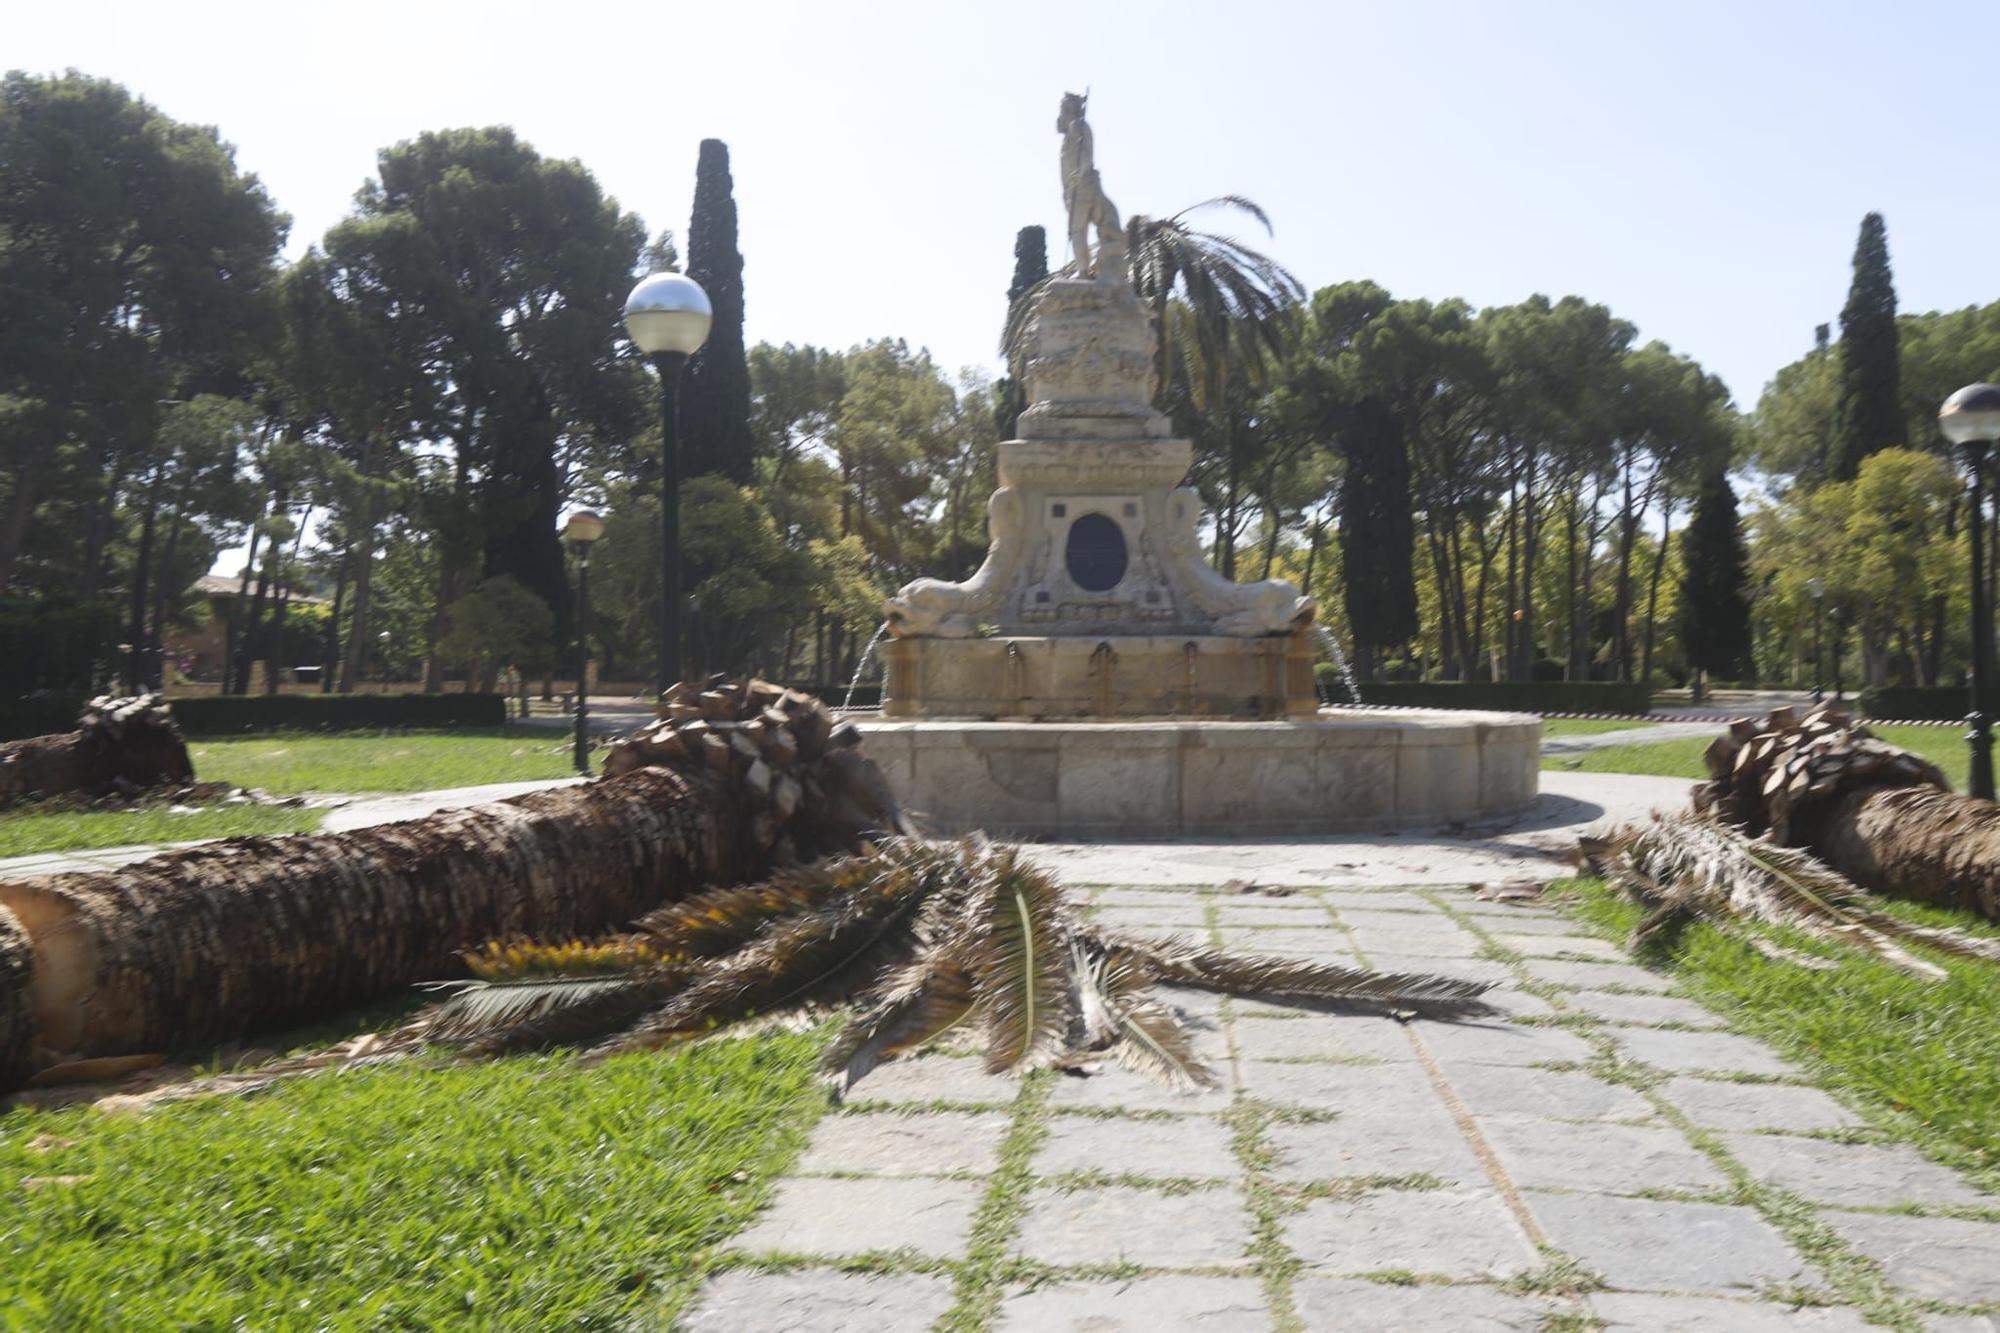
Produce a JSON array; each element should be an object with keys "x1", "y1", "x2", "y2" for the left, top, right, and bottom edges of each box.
[{"x1": 860, "y1": 709, "x2": 1542, "y2": 839}]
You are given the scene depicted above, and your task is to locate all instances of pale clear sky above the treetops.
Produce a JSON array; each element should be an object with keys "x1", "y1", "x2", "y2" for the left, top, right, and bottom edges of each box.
[{"x1": 11, "y1": 0, "x2": 2000, "y2": 406}]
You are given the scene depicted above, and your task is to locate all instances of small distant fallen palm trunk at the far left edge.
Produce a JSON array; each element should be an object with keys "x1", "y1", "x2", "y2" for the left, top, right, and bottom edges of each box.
[{"x1": 0, "y1": 695, "x2": 194, "y2": 805}]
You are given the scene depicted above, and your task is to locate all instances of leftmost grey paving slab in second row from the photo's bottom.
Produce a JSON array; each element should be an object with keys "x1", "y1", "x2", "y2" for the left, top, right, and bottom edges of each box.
[{"x1": 732, "y1": 1175, "x2": 982, "y2": 1259}]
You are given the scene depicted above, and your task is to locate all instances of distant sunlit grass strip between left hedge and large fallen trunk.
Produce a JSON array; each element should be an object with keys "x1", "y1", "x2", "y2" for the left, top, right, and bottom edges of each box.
[{"x1": 188, "y1": 729, "x2": 574, "y2": 793}]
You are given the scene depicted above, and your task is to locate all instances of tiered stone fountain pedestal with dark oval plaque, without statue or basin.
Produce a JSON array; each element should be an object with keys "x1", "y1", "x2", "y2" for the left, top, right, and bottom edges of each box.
[{"x1": 884, "y1": 280, "x2": 1314, "y2": 719}]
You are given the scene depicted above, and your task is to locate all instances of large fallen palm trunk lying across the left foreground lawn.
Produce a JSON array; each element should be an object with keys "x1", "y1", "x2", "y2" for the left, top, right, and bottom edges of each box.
[{"x1": 0, "y1": 683, "x2": 902, "y2": 1088}]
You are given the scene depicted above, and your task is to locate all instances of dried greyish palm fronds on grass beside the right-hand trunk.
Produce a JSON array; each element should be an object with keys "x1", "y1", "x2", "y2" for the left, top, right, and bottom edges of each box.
[{"x1": 1594, "y1": 815, "x2": 2000, "y2": 981}]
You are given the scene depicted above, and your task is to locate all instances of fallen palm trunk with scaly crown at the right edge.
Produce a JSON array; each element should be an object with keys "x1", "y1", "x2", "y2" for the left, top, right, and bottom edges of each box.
[{"x1": 1694, "y1": 705, "x2": 2000, "y2": 921}]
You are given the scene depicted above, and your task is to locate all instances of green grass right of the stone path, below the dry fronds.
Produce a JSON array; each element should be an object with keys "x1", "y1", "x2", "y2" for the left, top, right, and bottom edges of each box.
[{"x1": 1560, "y1": 876, "x2": 2000, "y2": 1189}]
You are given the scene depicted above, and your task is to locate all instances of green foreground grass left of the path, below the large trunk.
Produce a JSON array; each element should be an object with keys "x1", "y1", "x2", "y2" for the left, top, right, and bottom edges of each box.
[{"x1": 0, "y1": 1035, "x2": 826, "y2": 1329}]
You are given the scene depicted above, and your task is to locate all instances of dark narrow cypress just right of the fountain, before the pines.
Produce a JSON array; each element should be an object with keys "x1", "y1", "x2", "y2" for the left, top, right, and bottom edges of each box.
[{"x1": 1340, "y1": 398, "x2": 1418, "y2": 677}]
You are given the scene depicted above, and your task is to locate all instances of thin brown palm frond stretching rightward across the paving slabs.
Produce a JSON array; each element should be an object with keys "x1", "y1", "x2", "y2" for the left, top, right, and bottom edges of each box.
[{"x1": 1098, "y1": 935, "x2": 1492, "y2": 1015}]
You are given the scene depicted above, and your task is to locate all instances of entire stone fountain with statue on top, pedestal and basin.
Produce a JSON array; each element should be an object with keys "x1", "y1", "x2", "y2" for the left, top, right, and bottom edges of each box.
[{"x1": 868, "y1": 94, "x2": 1540, "y2": 837}]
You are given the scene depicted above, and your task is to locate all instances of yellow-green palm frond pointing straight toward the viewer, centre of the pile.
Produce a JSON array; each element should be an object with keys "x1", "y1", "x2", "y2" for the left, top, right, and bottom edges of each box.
[{"x1": 966, "y1": 847, "x2": 1074, "y2": 1073}]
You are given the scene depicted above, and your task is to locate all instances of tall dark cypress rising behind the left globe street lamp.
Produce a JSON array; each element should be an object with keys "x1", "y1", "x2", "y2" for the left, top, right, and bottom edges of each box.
[{"x1": 680, "y1": 138, "x2": 754, "y2": 484}]
